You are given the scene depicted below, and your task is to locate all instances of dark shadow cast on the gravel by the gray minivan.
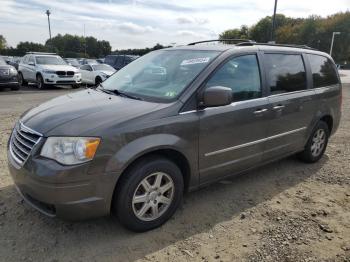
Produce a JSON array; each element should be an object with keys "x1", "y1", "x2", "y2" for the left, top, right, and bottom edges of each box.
[{"x1": 0, "y1": 155, "x2": 328, "y2": 261}]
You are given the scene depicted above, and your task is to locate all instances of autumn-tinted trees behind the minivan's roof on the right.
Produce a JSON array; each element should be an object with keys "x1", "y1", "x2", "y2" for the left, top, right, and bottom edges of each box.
[{"x1": 219, "y1": 11, "x2": 350, "y2": 64}]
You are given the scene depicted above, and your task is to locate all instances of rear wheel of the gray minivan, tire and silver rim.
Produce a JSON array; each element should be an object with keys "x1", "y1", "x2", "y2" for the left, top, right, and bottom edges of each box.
[{"x1": 298, "y1": 121, "x2": 330, "y2": 163}]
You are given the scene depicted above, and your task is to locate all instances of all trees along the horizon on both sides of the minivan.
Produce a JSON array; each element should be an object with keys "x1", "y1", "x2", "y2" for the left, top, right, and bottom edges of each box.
[{"x1": 0, "y1": 11, "x2": 350, "y2": 64}]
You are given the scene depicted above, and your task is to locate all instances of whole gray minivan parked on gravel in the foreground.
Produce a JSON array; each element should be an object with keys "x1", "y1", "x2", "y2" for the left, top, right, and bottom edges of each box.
[{"x1": 8, "y1": 42, "x2": 341, "y2": 231}]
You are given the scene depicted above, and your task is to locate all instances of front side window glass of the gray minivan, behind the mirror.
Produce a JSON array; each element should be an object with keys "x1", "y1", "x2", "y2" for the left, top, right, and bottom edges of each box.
[{"x1": 206, "y1": 55, "x2": 261, "y2": 101}]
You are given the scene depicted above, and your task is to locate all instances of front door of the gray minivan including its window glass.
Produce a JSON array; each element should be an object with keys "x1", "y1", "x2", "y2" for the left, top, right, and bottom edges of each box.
[{"x1": 199, "y1": 54, "x2": 269, "y2": 184}]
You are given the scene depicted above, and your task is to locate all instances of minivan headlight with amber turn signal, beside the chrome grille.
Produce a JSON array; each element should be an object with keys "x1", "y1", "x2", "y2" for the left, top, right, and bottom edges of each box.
[{"x1": 40, "y1": 137, "x2": 100, "y2": 165}]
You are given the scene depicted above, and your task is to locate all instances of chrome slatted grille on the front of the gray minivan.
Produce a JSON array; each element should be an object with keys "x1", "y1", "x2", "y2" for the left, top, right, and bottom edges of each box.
[{"x1": 10, "y1": 123, "x2": 42, "y2": 165}]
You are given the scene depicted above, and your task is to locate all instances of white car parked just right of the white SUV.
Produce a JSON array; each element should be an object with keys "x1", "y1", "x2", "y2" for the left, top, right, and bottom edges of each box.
[{"x1": 80, "y1": 64, "x2": 116, "y2": 86}]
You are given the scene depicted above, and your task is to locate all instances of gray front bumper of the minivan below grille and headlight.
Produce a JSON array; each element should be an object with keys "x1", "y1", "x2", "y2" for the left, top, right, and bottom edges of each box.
[{"x1": 7, "y1": 144, "x2": 115, "y2": 220}]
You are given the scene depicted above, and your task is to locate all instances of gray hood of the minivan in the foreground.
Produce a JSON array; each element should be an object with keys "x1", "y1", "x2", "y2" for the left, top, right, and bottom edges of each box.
[{"x1": 21, "y1": 89, "x2": 159, "y2": 136}]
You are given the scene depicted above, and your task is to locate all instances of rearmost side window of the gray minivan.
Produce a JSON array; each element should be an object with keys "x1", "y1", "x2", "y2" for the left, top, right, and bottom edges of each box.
[{"x1": 308, "y1": 54, "x2": 339, "y2": 88}]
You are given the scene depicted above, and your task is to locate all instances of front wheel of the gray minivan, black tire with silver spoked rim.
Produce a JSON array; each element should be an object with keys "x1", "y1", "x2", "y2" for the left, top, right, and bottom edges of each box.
[{"x1": 112, "y1": 156, "x2": 184, "y2": 232}]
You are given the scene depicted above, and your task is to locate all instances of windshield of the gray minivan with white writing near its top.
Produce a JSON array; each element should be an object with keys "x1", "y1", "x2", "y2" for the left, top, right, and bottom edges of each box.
[{"x1": 103, "y1": 50, "x2": 219, "y2": 102}]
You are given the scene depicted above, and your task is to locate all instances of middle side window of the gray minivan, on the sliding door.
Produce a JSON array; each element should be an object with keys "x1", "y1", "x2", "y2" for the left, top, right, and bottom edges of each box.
[{"x1": 264, "y1": 54, "x2": 307, "y2": 94}]
